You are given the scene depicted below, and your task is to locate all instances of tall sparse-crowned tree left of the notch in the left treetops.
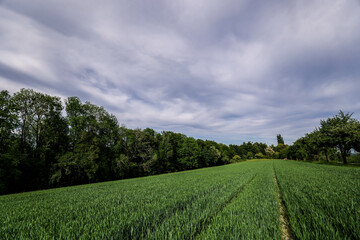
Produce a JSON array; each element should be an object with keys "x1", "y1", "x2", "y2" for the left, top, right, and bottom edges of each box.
[{"x1": 12, "y1": 89, "x2": 67, "y2": 190}]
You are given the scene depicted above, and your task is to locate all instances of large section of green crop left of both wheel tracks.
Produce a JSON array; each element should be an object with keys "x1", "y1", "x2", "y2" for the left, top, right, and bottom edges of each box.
[{"x1": 0, "y1": 161, "x2": 261, "y2": 239}]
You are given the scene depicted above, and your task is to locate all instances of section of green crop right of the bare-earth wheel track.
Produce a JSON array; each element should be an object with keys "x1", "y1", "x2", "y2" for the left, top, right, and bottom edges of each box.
[{"x1": 274, "y1": 161, "x2": 360, "y2": 239}]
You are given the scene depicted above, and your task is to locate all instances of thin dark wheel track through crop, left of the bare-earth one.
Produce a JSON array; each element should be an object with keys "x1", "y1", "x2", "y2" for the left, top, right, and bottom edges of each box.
[{"x1": 191, "y1": 173, "x2": 257, "y2": 239}]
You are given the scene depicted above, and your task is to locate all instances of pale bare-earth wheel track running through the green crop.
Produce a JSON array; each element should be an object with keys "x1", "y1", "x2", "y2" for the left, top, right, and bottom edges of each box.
[{"x1": 273, "y1": 167, "x2": 296, "y2": 240}]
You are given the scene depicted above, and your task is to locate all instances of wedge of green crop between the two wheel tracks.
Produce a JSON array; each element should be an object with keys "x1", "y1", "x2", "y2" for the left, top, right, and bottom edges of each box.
[{"x1": 200, "y1": 161, "x2": 281, "y2": 239}]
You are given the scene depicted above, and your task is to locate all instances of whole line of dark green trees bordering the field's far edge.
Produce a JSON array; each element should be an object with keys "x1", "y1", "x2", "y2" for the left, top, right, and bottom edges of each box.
[{"x1": 0, "y1": 89, "x2": 360, "y2": 194}]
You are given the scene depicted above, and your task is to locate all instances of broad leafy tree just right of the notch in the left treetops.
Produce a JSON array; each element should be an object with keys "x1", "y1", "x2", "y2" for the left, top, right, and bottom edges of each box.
[{"x1": 52, "y1": 97, "x2": 119, "y2": 184}]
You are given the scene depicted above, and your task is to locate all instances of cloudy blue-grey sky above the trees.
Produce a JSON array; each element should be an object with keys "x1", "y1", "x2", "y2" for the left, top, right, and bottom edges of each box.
[{"x1": 0, "y1": 0, "x2": 360, "y2": 144}]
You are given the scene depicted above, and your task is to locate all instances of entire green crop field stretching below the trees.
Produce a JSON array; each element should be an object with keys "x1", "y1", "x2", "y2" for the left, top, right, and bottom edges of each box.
[{"x1": 0, "y1": 160, "x2": 360, "y2": 239}]
